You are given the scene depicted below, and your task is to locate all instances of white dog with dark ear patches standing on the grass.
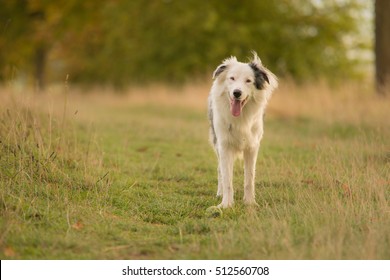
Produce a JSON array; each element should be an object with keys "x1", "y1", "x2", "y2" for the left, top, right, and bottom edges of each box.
[{"x1": 209, "y1": 52, "x2": 278, "y2": 208}]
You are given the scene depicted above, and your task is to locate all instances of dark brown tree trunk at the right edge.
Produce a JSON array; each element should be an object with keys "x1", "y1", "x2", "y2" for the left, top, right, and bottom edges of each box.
[{"x1": 375, "y1": 0, "x2": 390, "y2": 95}]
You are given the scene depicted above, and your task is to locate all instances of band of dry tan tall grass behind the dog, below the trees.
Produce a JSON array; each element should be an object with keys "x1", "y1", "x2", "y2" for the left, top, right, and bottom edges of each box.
[{"x1": 0, "y1": 81, "x2": 390, "y2": 127}]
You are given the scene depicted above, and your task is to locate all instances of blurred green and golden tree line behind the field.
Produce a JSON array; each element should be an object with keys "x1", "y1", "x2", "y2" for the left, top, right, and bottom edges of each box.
[{"x1": 0, "y1": 0, "x2": 372, "y2": 88}]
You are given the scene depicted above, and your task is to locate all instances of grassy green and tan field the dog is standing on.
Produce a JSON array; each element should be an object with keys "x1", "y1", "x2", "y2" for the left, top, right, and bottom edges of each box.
[{"x1": 0, "y1": 82, "x2": 390, "y2": 259}]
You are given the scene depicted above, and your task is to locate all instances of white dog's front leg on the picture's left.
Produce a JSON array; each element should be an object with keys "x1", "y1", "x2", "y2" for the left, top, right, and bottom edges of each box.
[{"x1": 218, "y1": 147, "x2": 234, "y2": 208}]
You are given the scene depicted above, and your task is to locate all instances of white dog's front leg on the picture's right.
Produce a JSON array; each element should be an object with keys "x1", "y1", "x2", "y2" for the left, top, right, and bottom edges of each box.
[{"x1": 244, "y1": 146, "x2": 259, "y2": 205}]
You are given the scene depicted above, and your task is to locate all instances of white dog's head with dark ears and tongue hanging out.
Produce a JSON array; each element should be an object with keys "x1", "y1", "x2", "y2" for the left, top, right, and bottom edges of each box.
[{"x1": 213, "y1": 52, "x2": 278, "y2": 117}]
